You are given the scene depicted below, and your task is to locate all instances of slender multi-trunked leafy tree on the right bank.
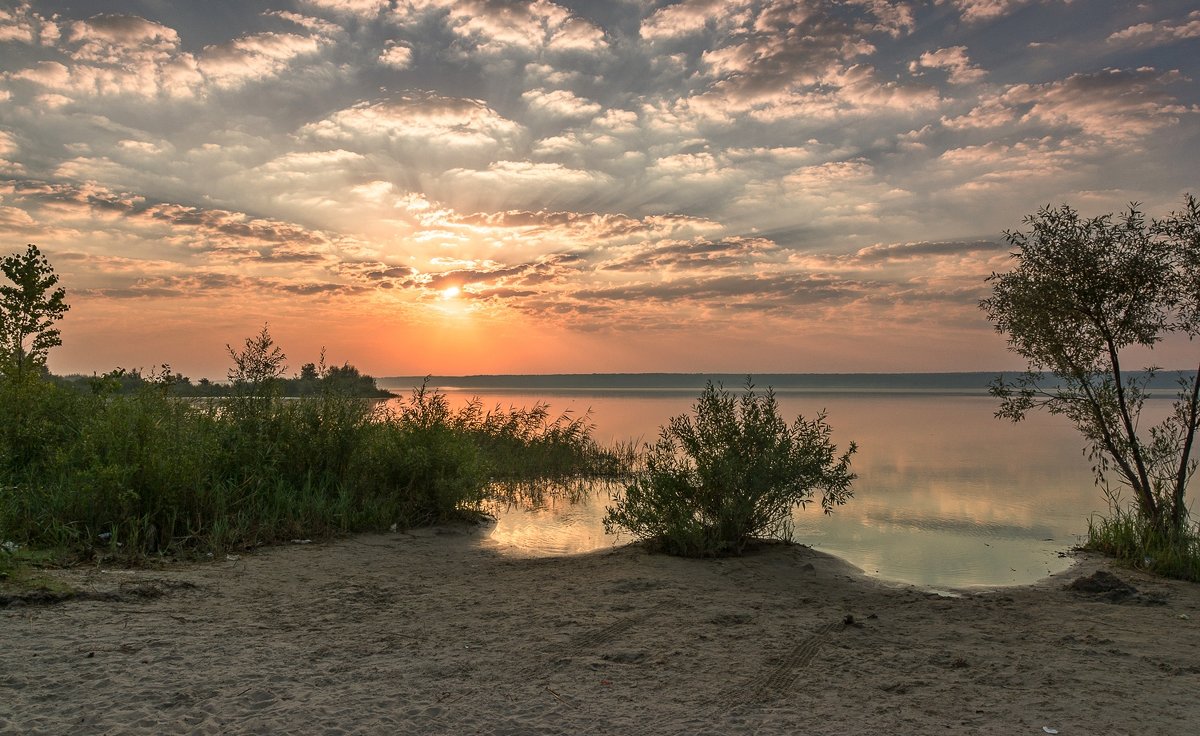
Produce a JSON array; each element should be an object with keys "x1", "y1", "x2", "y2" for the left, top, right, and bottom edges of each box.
[{"x1": 980, "y1": 195, "x2": 1200, "y2": 538}]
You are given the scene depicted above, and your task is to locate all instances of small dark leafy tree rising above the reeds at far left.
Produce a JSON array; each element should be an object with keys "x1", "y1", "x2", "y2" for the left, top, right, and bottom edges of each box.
[{"x1": 0, "y1": 244, "x2": 71, "y2": 383}]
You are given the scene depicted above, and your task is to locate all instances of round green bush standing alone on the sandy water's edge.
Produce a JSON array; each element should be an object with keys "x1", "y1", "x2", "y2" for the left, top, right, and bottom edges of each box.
[{"x1": 605, "y1": 382, "x2": 856, "y2": 556}]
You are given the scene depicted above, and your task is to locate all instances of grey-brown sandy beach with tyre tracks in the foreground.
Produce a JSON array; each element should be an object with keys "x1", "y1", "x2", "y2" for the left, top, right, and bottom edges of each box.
[{"x1": 0, "y1": 528, "x2": 1200, "y2": 736}]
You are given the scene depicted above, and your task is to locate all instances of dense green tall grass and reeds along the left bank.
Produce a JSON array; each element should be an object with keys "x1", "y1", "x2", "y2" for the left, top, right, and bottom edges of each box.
[{"x1": 0, "y1": 379, "x2": 623, "y2": 556}]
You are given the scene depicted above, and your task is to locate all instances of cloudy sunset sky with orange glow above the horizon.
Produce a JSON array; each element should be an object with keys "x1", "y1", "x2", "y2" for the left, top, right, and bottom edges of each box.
[{"x1": 0, "y1": 0, "x2": 1200, "y2": 378}]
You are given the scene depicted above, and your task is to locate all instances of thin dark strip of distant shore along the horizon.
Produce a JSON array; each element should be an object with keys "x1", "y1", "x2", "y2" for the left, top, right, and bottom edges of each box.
[{"x1": 378, "y1": 371, "x2": 1183, "y2": 395}]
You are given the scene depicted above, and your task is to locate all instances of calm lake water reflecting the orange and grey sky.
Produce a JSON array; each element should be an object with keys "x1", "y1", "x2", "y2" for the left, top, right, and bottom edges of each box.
[{"x1": 391, "y1": 390, "x2": 1106, "y2": 587}]
